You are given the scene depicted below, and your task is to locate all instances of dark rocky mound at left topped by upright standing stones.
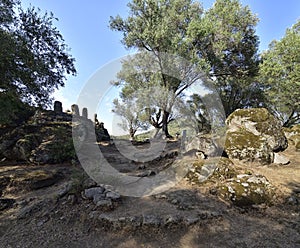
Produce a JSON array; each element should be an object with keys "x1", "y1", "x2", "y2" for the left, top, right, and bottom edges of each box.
[{"x1": 0, "y1": 101, "x2": 110, "y2": 164}]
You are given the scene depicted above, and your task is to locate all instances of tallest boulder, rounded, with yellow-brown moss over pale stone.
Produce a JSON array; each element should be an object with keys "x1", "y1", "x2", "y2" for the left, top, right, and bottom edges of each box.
[{"x1": 225, "y1": 108, "x2": 288, "y2": 164}]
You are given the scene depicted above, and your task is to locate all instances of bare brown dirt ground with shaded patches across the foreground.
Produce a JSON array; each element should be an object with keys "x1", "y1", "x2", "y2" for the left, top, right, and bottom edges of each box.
[{"x1": 0, "y1": 142, "x2": 300, "y2": 248}]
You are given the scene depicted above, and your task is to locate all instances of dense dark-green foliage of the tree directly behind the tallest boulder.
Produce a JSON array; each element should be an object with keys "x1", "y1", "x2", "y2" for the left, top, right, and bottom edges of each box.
[{"x1": 189, "y1": 0, "x2": 263, "y2": 116}]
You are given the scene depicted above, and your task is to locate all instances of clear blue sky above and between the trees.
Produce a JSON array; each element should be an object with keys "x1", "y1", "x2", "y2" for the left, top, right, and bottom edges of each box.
[{"x1": 22, "y1": 0, "x2": 300, "y2": 135}]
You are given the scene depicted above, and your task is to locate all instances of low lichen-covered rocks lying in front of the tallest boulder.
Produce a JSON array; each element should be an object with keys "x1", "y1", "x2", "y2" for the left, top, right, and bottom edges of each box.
[{"x1": 186, "y1": 157, "x2": 275, "y2": 207}]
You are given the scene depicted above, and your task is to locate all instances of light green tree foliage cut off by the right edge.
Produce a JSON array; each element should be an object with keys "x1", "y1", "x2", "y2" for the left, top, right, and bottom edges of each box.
[{"x1": 260, "y1": 20, "x2": 300, "y2": 127}]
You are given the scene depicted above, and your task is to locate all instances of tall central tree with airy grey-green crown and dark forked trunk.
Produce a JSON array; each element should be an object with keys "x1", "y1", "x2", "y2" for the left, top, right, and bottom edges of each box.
[{"x1": 110, "y1": 0, "x2": 203, "y2": 136}]
